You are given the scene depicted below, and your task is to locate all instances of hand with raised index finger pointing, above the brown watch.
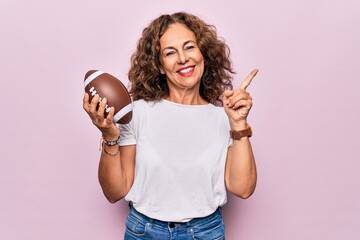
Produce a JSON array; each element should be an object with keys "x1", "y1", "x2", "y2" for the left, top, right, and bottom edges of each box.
[{"x1": 223, "y1": 69, "x2": 258, "y2": 130}]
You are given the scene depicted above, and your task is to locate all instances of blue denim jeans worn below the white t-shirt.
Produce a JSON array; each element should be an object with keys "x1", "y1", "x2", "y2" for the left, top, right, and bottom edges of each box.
[{"x1": 124, "y1": 205, "x2": 225, "y2": 240}]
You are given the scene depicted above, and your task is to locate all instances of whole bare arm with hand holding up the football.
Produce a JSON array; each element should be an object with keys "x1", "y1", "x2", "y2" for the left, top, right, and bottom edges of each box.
[{"x1": 83, "y1": 93, "x2": 136, "y2": 203}]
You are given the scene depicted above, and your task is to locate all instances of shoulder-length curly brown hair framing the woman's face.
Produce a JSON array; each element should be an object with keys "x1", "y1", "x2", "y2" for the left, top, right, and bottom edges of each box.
[{"x1": 129, "y1": 12, "x2": 235, "y2": 105}]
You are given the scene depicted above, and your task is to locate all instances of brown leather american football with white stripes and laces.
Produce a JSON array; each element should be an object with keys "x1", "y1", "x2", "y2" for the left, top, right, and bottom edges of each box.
[{"x1": 84, "y1": 70, "x2": 132, "y2": 124}]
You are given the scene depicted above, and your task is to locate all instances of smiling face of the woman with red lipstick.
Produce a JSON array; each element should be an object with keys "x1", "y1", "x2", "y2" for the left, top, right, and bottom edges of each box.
[{"x1": 160, "y1": 23, "x2": 204, "y2": 99}]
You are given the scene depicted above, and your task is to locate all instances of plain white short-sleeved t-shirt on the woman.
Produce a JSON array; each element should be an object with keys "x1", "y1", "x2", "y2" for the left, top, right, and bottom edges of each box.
[{"x1": 119, "y1": 100, "x2": 231, "y2": 222}]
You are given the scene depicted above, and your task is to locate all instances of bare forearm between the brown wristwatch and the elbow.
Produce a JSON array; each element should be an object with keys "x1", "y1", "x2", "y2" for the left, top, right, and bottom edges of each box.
[{"x1": 226, "y1": 137, "x2": 257, "y2": 198}]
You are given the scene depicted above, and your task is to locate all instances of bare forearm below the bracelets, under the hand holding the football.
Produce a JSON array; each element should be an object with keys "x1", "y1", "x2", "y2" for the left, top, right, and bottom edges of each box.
[{"x1": 99, "y1": 144, "x2": 128, "y2": 203}]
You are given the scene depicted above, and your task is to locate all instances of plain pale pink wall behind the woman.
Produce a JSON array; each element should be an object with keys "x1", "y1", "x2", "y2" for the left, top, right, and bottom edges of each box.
[{"x1": 0, "y1": 0, "x2": 360, "y2": 240}]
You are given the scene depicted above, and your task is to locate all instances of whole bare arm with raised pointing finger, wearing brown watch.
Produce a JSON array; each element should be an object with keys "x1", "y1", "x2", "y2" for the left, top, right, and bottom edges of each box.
[{"x1": 223, "y1": 70, "x2": 257, "y2": 198}]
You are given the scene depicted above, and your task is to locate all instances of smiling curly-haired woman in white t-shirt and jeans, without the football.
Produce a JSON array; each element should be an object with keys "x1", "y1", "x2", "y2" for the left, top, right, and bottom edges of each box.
[{"x1": 83, "y1": 12, "x2": 257, "y2": 240}]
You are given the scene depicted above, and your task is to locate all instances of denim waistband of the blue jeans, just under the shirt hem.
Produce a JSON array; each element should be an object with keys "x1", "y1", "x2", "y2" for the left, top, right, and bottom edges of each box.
[{"x1": 129, "y1": 202, "x2": 222, "y2": 228}]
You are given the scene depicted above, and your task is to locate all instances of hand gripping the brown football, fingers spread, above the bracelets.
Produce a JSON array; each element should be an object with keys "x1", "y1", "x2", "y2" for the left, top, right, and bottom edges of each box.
[{"x1": 83, "y1": 93, "x2": 120, "y2": 141}]
